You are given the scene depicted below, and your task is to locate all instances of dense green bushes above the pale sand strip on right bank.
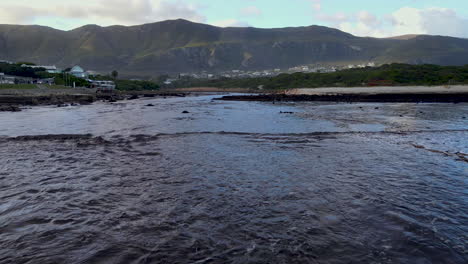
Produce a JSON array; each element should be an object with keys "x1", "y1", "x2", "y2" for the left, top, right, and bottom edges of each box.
[{"x1": 173, "y1": 63, "x2": 468, "y2": 90}]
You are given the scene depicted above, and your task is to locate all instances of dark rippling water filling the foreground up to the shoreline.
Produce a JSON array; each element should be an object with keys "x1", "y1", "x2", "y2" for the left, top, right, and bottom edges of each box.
[{"x1": 0, "y1": 95, "x2": 468, "y2": 263}]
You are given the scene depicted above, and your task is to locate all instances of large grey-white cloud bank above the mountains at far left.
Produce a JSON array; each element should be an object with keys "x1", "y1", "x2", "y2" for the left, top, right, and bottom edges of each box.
[{"x1": 0, "y1": 0, "x2": 206, "y2": 28}]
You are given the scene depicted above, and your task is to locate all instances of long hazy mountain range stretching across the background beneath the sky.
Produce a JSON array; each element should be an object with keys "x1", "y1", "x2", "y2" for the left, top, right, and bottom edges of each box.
[{"x1": 0, "y1": 19, "x2": 468, "y2": 76}]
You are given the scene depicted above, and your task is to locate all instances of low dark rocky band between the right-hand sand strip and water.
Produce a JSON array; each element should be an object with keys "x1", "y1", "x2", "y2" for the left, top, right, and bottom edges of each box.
[{"x1": 215, "y1": 93, "x2": 468, "y2": 103}]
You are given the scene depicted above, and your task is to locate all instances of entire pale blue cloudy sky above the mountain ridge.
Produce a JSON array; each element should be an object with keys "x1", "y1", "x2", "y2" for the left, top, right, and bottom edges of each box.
[{"x1": 0, "y1": 0, "x2": 468, "y2": 38}]
